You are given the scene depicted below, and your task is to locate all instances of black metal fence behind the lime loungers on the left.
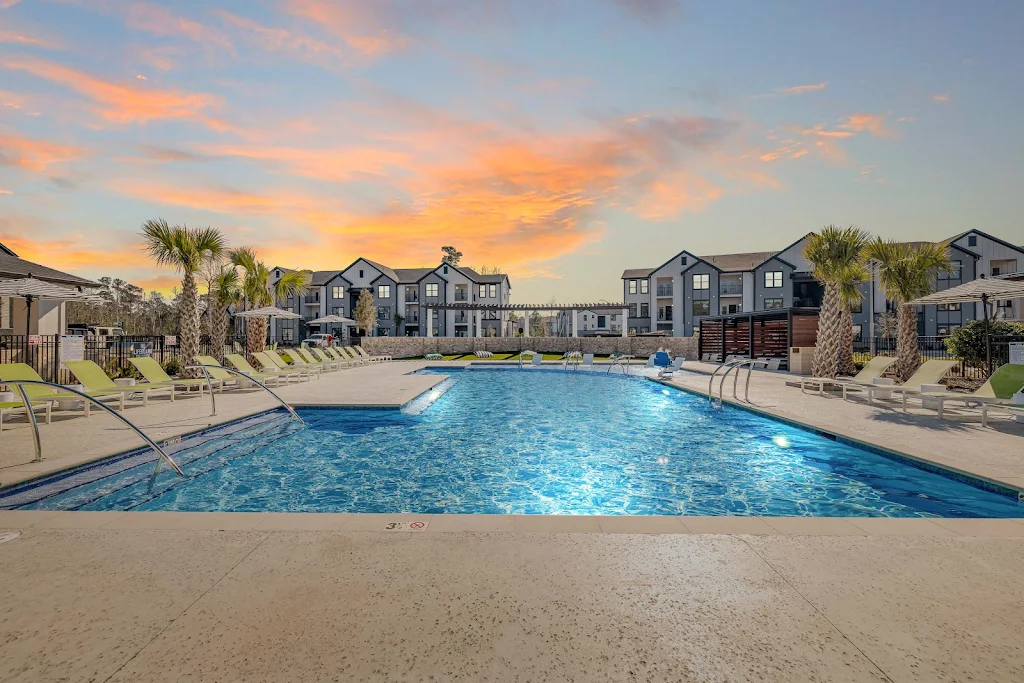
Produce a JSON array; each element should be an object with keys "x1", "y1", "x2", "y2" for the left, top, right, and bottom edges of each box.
[{"x1": 0, "y1": 335, "x2": 246, "y2": 384}]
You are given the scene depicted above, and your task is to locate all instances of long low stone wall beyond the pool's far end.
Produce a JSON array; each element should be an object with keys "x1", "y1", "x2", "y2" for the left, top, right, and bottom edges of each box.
[{"x1": 361, "y1": 337, "x2": 697, "y2": 359}]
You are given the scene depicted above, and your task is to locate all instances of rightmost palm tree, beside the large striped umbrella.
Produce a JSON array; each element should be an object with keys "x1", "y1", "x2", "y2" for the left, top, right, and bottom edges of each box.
[{"x1": 865, "y1": 238, "x2": 953, "y2": 380}]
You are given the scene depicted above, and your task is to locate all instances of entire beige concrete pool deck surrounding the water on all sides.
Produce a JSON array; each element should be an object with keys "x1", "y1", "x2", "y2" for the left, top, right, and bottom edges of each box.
[{"x1": 0, "y1": 362, "x2": 1024, "y2": 683}]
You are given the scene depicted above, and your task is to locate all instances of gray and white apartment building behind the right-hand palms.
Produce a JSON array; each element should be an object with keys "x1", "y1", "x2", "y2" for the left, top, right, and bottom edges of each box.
[{"x1": 622, "y1": 230, "x2": 1024, "y2": 338}]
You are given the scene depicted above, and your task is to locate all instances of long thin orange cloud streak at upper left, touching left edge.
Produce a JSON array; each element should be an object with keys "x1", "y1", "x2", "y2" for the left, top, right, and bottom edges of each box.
[{"x1": 0, "y1": 58, "x2": 224, "y2": 125}]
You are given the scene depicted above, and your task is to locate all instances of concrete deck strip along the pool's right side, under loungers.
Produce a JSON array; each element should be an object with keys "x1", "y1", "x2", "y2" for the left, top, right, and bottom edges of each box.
[{"x1": 671, "y1": 362, "x2": 1024, "y2": 490}]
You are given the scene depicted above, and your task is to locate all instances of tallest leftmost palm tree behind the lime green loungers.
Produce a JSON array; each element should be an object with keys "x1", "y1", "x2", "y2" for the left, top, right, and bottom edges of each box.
[{"x1": 142, "y1": 218, "x2": 227, "y2": 376}]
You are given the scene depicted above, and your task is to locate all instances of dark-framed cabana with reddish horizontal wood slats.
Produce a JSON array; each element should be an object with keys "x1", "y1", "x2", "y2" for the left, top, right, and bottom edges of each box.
[{"x1": 697, "y1": 308, "x2": 818, "y2": 358}]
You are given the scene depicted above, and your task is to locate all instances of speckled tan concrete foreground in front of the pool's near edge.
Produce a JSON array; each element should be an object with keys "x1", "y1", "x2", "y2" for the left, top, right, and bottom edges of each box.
[{"x1": 0, "y1": 528, "x2": 1024, "y2": 683}]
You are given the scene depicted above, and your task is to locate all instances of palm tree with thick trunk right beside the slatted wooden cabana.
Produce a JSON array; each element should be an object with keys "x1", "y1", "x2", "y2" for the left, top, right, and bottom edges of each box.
[{"x1": 804, "y1": 225, "x2": 869, "y2": 377}]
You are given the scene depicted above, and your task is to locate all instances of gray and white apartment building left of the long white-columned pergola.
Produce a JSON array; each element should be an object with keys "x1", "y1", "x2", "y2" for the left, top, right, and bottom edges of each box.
[{"x1": 271, "y1": 258, "x2": 512, "y2": 342}]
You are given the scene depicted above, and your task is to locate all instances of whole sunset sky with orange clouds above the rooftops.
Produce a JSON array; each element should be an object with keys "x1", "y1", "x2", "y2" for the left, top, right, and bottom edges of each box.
[{"x1": 0, "y1": 0, "x2": 1024, "y2": 303}]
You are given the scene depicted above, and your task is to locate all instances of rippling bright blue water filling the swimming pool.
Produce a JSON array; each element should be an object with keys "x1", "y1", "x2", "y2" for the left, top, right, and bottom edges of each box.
[{"x1": 0, "y1": 369, "x2": 1024, "y2": 517}]
